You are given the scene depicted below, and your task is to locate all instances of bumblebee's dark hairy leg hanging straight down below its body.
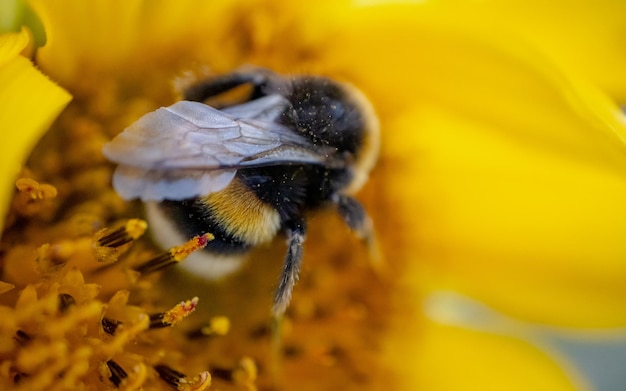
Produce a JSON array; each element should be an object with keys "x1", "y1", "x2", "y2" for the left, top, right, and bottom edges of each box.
[{"x1": 272, "y1": 220, "x2": 306, "y2": 319}]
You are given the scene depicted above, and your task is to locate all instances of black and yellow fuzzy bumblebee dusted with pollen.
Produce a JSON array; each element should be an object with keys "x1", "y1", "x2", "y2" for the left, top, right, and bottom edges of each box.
[{"x1": 103, "y1": 69, "x2": 379, "y2": 316}]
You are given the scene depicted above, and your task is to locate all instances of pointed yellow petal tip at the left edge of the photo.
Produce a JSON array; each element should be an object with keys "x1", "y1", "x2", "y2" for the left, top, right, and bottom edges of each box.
[{"x1": 0, "y1": 30, "x2": 71, "y2": 236}]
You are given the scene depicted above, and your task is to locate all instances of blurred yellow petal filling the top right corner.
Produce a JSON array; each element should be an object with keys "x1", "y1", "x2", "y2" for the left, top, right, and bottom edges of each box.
[{"x1": 426, "y1": 0, "x2": 626, "y2": 102}]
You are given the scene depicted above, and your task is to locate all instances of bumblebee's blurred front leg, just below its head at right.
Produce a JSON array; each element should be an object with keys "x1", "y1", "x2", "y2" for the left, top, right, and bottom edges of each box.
[{"x1": 331, "y1": 194, "x2": 382, "y2": 272}]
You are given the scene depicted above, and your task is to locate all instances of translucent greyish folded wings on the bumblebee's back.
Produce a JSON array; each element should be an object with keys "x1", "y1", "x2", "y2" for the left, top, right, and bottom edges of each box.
[{"x1": 103, "y1": 95, "x2": 334, "y2": 201}]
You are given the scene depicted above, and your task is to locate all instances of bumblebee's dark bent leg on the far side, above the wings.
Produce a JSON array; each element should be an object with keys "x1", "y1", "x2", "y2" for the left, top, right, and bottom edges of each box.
[{"x1": 183, "y1": 72, "x2": 267, "y2": 102}]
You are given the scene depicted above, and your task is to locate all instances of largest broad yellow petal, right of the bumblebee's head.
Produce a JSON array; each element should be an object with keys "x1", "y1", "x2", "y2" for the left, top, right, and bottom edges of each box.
[{"x1": 325, "y1": 5, "x2": 626, "y2": 327}]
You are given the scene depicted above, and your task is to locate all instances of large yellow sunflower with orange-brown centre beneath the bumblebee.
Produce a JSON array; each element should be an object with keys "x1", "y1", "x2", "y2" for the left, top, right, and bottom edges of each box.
[{"x1": 0, "y1": 0, "x2": 626, "y2": 390}]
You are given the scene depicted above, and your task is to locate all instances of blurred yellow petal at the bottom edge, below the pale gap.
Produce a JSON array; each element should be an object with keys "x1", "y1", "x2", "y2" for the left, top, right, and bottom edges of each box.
[{"x1": 384, "y1": 321, "x2": 587, "y2": 391}]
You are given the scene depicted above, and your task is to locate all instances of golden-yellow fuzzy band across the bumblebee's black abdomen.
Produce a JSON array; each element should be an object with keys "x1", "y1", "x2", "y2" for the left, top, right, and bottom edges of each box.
[{"x1": 203, "y1": 179, "x2": 280, "y2": 245}]
